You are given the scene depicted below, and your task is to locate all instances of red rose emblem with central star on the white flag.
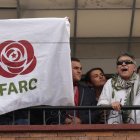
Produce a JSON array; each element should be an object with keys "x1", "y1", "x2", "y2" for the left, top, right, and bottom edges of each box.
[{"x1": 0, "y1": 40, "x2": 36, "y2": 78}]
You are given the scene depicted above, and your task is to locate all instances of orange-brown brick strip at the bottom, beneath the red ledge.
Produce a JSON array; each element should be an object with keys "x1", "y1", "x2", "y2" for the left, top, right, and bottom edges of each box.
[{"x1": 0, "y1": 131, "x2": 140, "y2": 140}]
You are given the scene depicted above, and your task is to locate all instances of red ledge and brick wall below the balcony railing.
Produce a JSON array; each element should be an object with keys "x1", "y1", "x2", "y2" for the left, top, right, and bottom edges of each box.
[{"x1": 0, "y1": 125, "x2": 140, "y2": 140}]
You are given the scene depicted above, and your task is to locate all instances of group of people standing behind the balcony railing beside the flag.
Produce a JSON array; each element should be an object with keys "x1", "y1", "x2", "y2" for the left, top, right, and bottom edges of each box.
[{"x1": 0, "y1": 53, "x2": 140, "y2": 124}]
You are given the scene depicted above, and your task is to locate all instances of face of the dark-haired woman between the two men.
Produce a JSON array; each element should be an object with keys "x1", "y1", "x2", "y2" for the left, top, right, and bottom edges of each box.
[{"x1": 90, "y1": 70, "x2": 106, "y2": 87}]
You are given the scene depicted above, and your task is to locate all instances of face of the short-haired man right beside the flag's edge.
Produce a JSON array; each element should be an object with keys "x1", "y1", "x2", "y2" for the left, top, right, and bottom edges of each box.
[{"x1": 71, "y1": 61, "x2": 82, "y2": 82}]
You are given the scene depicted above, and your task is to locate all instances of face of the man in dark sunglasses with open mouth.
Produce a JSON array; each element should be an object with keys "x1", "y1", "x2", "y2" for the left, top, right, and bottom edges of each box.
[{"x1": 117, "y1": 56, "x2": 136, "y2": 80}]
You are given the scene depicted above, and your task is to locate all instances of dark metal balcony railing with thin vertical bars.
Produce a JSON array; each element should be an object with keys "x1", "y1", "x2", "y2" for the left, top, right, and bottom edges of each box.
[{"x1": 0, "y1": 105, "x2": 140, "y2": 125}]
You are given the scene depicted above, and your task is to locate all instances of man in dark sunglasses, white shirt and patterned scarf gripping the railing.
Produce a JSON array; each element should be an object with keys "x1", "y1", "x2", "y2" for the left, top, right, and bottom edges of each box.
[{"x1": 98, "y1": 53, "x2": 140, "y2": 124}]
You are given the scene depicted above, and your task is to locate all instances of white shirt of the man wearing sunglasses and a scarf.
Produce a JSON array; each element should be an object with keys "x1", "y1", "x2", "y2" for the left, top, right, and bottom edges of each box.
[{"x1": 97, "y1": 76, "x2": 140, "y2": 124}]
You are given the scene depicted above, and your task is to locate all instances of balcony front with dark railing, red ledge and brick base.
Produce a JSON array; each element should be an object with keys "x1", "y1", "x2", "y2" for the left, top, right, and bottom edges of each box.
[{"x1": 0, "y1": 106, "x2": 140, "y2": 140}]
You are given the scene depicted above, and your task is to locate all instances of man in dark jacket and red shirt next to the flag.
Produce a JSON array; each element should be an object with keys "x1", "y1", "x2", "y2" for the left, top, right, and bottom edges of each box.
[{"x1": 65, "y1": 58, "x2": 98, "y2": 124}]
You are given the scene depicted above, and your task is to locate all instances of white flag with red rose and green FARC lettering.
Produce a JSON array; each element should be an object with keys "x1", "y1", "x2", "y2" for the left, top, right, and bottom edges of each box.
[{"x1": 0, "y1": 18, "x2": 74, "y2": 114}]
